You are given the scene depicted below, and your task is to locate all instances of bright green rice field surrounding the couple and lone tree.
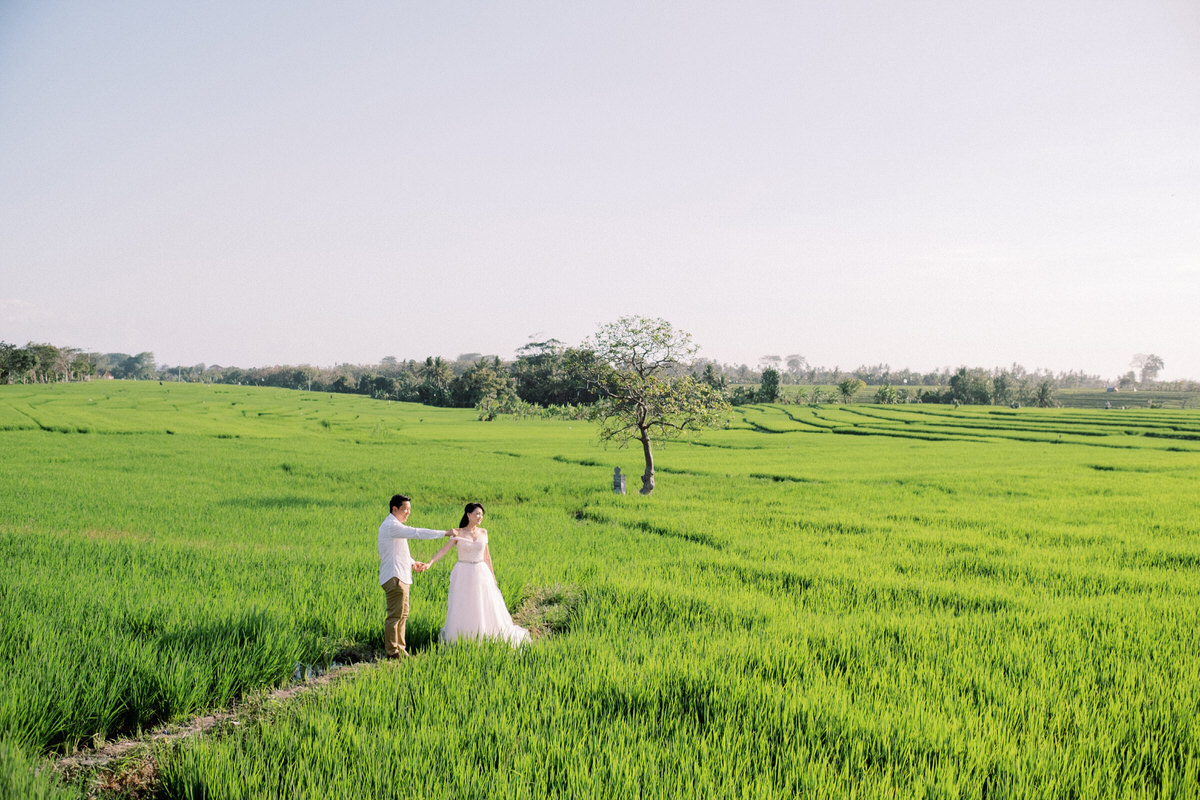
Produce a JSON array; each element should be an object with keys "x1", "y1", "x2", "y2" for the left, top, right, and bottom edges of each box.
[{"x1": 0, "y1": 380, "x2": 1200, "y2": 798}]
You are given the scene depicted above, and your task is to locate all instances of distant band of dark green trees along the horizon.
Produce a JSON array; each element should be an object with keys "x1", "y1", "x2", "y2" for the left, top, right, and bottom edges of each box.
[{"x1": 0, "y1": 339, "x2": 1200, "y2": 408}]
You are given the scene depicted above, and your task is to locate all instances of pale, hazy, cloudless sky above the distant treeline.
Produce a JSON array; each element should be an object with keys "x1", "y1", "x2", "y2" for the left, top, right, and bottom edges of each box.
[{"x1": 0, "y1": 0, "x2": 1200, "y2": 379}]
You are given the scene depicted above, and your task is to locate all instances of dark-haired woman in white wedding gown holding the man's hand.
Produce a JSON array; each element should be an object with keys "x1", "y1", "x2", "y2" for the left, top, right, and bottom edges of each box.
[{"x1": 426, "y1": 503, "x2": 529, "y2": 645}]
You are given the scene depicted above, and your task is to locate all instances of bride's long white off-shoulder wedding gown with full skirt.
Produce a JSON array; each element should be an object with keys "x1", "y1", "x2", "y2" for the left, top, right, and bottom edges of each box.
[{"x1": 442, "y1": 534, "x2": 529, "y2": 644}]
